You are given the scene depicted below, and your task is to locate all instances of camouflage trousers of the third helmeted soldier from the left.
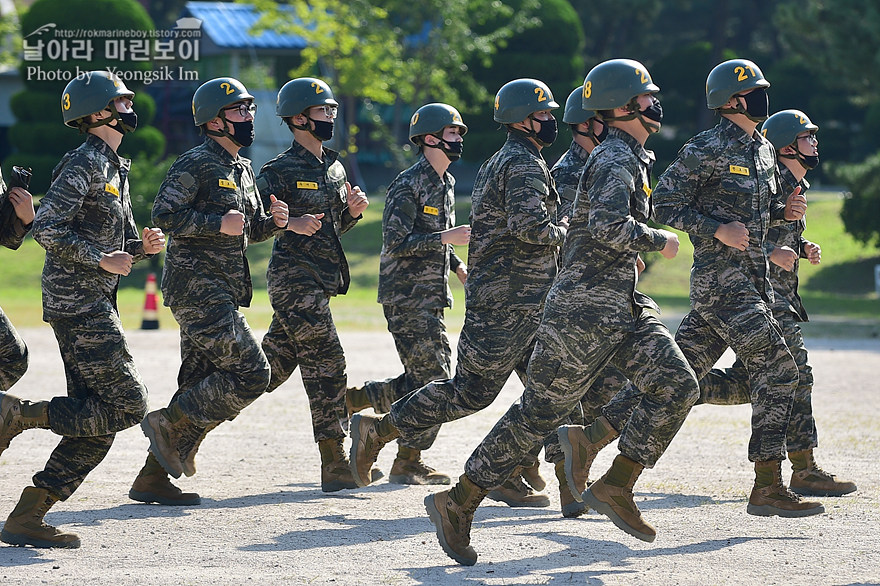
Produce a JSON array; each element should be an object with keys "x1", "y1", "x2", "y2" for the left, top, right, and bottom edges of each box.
[{"x1": 263, "y1": 290, "x2": 348, "y2": 442}]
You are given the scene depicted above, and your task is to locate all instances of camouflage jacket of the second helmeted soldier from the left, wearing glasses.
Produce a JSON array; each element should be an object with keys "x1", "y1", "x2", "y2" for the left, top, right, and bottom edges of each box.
[{"x1": 153, "y1": 138, "x2": 283, "y2": 307}]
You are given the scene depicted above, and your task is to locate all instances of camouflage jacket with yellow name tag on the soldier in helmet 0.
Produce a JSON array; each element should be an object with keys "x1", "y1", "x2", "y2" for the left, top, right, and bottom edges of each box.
[{"x1": 378, "y1": 155, "x2": 462, "y2": 309}]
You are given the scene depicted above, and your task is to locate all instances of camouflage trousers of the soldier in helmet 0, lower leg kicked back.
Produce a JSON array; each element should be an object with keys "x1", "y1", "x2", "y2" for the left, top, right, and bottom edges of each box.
[{"x1": 363, "y1": 305, "x2": 452, "y2": 413}]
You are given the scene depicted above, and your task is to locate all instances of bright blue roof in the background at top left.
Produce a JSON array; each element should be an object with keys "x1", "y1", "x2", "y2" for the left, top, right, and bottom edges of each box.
[{"x1": 186, "y1": 2, "x2": 306, "y2": 49}]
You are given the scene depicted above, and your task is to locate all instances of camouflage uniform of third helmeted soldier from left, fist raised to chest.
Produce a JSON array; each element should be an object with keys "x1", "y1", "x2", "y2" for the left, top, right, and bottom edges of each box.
[{"x1": 257, "y1": 141, "x2": 360, "y2": 442}]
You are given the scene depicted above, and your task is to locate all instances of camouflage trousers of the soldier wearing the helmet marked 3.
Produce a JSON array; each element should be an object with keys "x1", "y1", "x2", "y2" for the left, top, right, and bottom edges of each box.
[{"x1": 34, "y1": 302, "x2": 147, "y2": 500}]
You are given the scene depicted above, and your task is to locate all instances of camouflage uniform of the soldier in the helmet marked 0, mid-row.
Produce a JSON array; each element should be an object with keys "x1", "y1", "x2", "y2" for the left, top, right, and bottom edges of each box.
[{"x1": 363, "y1": 155, "x2": 462, "y2": 413}]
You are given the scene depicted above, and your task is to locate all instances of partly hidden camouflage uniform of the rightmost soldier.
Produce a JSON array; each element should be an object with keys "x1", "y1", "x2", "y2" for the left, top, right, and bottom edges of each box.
[{"x1": 700, "y1": 165, "x2": 819, "y2": 452}]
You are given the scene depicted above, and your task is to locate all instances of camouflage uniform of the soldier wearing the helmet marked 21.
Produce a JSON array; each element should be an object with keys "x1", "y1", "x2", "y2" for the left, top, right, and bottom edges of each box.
[{"x1": 654, "y1": 118, "x2": 798, "y2": 462}]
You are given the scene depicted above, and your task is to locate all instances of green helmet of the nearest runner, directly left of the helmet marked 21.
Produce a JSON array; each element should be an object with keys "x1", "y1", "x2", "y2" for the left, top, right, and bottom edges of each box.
[{"x1": 581, "y1": 59, "x2": 660, "y2": 110}]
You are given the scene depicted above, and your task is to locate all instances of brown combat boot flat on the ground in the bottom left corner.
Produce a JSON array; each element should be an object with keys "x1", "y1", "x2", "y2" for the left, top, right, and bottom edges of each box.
[{"x1": 0, "y1": 486, "x2": 80, "y2": 549}]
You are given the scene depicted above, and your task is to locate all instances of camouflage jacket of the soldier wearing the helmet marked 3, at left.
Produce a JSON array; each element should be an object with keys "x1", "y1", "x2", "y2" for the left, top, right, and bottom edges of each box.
[{"x1": 34, "y1": 134, "x2": 146, "y2": 321}]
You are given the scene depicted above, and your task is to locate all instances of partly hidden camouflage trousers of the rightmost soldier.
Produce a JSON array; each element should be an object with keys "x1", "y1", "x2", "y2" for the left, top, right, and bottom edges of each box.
[{"x1": 698, "y1": 309, "x2": 819, "y2": 452}]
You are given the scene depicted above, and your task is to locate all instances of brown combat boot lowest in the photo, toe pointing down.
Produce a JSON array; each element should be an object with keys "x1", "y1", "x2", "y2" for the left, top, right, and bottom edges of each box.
[{"x1": 425, "y1": 474, "x2": 488, "y2": 566}]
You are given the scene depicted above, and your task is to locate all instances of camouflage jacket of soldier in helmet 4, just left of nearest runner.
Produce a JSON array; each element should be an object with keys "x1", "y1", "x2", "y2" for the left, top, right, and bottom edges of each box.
[{"x1": 465, "y1": 132, "x2": 565, "y2": 309}]
